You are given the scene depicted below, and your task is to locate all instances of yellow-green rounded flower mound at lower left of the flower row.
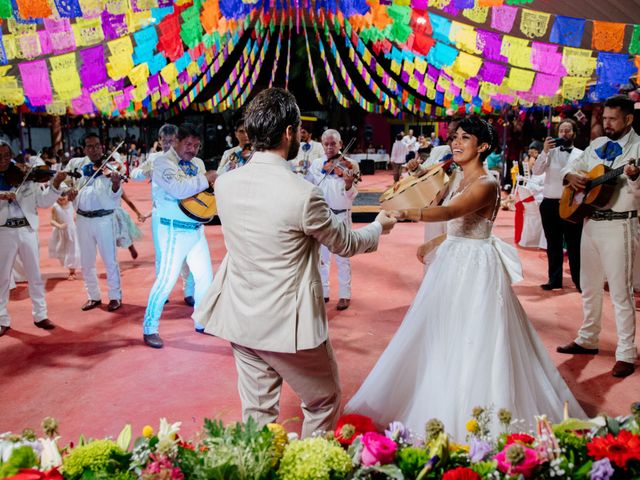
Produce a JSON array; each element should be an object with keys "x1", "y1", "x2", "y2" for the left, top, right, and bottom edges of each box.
[{"x1": 62, "y1": 440, "x2": 130, "y2": 480}]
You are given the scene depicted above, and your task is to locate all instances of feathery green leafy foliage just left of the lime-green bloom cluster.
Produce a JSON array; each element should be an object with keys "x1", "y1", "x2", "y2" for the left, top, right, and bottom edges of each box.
[{"x1": 177, "y1": 418, "x2": 273, "y2": 480}]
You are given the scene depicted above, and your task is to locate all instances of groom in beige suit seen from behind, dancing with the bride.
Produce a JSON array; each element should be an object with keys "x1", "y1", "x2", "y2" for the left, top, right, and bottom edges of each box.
[{"x1": 194, "y1": 88, "x2": 396, "y2": 437}]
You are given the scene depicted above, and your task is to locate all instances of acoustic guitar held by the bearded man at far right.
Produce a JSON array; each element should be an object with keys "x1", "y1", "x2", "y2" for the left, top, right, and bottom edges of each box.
[{"x1": 560, "y1": 160, "x2": 635, "y2": 223}]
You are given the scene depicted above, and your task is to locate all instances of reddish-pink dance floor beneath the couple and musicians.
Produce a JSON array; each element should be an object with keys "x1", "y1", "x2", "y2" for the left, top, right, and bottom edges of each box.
[{"x1": 0, "y1": 171, "x2": 640, "y2": 441}]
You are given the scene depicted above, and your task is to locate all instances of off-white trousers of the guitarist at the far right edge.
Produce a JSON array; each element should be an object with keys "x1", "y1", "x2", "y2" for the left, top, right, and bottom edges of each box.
[{"x1": 575, "y1": 218, "x2": 638, "y2": 363}]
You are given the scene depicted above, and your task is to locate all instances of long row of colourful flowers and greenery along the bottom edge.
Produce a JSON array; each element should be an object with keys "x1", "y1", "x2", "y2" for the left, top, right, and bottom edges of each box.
[{"x1": 0, "y1": 403, "x2": 640, "y2": 480}]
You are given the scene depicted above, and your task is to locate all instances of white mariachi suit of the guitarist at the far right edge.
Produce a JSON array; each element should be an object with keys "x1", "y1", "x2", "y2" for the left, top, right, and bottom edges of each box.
[{"x1": 562, "y1": 130, "x2": 640, "y2": 363}]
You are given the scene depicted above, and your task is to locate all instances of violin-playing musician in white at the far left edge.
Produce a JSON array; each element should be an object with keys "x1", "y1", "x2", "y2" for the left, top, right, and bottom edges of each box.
[{"x1": 0, "y1": 140, "x2": 67, "y2": 337}]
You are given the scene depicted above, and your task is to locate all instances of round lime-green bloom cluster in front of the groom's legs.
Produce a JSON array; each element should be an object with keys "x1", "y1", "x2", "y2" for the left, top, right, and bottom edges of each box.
[{"x1": 278, "y1": 437, "x2": 353, "y2": 480}]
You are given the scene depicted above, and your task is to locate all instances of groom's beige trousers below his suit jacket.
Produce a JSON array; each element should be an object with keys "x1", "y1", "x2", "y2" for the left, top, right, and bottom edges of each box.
[{"x1": 231, "y1": 340, "x2": 341, "y2": 438}]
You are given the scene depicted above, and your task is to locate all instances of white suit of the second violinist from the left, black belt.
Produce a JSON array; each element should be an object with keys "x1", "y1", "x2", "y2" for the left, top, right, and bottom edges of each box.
[{"x1": 70, "y1": 157, "x2": 122, "y2": 300}]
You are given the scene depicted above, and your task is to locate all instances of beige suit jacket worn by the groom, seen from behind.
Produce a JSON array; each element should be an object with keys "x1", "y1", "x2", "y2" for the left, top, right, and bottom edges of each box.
[{"x1": 193, "y1": 152, "x2": 382, "y2": 353}]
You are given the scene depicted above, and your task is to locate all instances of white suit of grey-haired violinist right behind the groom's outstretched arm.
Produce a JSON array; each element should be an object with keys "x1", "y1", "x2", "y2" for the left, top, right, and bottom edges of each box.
[{"x1": 309, "y1": 155, "x2": 358, "y2": 299}]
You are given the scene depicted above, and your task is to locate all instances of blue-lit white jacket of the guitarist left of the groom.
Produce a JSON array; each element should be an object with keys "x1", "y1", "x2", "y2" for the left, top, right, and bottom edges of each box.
[{"x1": 152, "y1": 148, "x2": 209, "y2": 223}]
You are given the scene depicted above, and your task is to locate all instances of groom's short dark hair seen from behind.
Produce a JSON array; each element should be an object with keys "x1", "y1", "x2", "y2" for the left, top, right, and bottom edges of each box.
[{"x1": 244, "y1": 88, "x2": 300, "y2": 152}]
